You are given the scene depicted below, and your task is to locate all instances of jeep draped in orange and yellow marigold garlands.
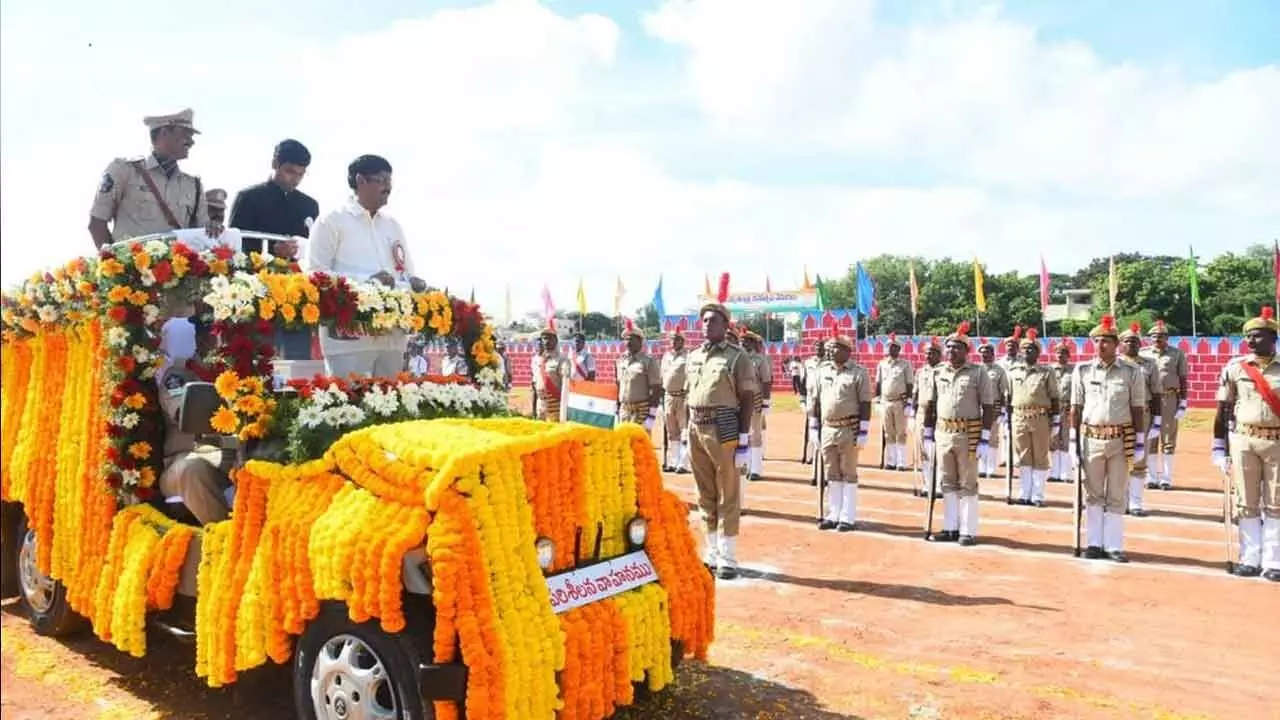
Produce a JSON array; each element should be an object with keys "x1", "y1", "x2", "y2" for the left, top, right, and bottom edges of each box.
[{"x1": 0, "y1": 237, "x2": 714, "y2": 720}]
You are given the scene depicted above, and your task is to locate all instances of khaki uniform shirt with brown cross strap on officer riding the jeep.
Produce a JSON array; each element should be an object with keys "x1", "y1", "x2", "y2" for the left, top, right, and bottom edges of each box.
[{"x1": 90, "y1": 155, "x2": 209, "y2": 242}]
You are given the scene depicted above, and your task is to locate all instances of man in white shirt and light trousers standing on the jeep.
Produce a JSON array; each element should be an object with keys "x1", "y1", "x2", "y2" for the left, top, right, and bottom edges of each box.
[{"x1": 306, "y1": 155, "x2": 426, "y2": 377}]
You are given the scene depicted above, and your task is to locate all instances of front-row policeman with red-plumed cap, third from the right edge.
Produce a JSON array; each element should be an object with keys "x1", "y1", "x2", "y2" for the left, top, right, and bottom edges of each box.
[{"x1": 920, "y1": 322, "x2": 1000, "y2": 546}]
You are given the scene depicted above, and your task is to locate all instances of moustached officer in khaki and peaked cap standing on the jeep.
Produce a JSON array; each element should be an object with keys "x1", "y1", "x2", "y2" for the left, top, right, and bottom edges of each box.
[{"x1": 88, "y1": 109, "x2": 221, "y2": 247}]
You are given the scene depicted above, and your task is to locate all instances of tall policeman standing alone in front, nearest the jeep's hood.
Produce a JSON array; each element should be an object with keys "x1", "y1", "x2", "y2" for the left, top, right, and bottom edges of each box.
[{"x1": 686, "y1": 302, "x2": 755, "y2": 580}]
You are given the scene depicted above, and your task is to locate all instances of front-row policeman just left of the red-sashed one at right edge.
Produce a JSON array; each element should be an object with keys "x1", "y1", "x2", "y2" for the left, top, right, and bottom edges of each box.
[{"x1": 1070, "y1": 315, "x2": 1149, "y2": 562}]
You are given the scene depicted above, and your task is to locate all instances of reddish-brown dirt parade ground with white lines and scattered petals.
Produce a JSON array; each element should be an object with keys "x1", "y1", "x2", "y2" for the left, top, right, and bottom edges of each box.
[{"x1": 3, "y1": 397, "x2": 1280, "y2": 720}]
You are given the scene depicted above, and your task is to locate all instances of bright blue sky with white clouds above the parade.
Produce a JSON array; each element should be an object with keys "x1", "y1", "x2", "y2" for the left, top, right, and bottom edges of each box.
[{"x1": 0, "y1": 0, "x2": 1280, "y2": 311}]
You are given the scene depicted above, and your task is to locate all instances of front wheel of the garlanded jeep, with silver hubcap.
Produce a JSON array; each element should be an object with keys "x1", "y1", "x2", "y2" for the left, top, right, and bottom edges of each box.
[{"x1": 293, "y1": 602, "x2": 435, "y2": 720}]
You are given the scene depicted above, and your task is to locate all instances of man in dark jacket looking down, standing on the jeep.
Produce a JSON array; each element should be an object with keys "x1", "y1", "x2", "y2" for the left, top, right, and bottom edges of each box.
[{"x1": 228, "y1": 140, "x2": 320, "y2": 258}]
